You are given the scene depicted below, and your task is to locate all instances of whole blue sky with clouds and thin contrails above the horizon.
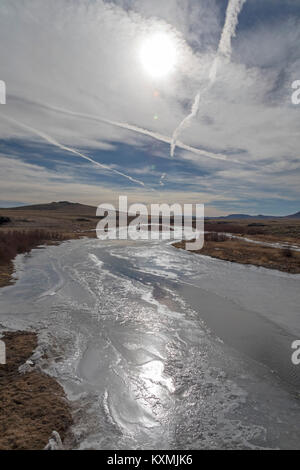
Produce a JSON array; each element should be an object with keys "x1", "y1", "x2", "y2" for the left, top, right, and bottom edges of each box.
[{"x1": 0, "y1": 0, "x2": 300, "y2": 216}]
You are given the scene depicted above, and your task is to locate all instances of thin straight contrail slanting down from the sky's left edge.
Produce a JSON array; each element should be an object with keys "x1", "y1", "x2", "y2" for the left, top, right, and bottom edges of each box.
[{"x1": 2, "y1": 115, "x2": 145, "y2": 186}]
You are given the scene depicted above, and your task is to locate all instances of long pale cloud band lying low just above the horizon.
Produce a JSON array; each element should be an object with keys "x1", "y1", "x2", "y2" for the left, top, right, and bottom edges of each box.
[{"x1": 0, "y1": 154, "x2": 233, "y2": 216}]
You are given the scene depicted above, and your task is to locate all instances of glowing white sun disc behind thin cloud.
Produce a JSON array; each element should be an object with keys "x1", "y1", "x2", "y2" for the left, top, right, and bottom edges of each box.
[{"x1": 140, "y1": 33, "x2": 176, "y2": 78}]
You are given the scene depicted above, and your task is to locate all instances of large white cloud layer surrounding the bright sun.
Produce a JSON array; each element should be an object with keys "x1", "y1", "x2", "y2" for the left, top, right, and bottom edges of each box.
[{"x1": 0, "y1": 0, "x2": 300, "y2": 211}]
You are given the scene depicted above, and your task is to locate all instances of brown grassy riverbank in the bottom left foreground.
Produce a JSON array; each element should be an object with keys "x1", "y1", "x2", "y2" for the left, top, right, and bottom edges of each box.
[{"x1": 0, "y1": 331, "x2": 72, "y2": 450}]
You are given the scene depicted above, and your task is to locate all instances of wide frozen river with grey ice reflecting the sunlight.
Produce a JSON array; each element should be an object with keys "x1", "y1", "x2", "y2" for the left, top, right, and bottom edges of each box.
[{"x1": 0, "y1": 240, "x2": 300, "y2": 449}]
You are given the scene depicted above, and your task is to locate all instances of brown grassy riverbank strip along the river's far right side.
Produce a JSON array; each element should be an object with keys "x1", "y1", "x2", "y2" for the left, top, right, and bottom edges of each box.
[{"x1": 173, "y1": 237, "x2": 300, "y2": 274}]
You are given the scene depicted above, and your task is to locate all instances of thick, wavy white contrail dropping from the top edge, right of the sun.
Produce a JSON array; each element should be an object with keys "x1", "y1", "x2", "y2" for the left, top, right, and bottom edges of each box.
[{"x1": 170, "y1": 0, "x2": 246, "y2": 157}]
